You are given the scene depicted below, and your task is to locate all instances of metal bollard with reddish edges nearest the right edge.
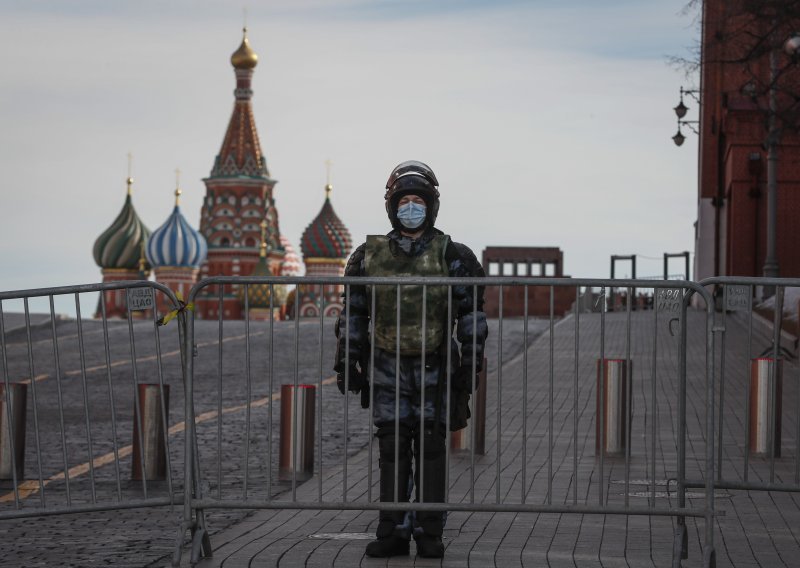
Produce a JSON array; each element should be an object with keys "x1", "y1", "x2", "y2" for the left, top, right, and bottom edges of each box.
[{"x1": 748, "y1": 357, "x2": 783, "y2": 457}]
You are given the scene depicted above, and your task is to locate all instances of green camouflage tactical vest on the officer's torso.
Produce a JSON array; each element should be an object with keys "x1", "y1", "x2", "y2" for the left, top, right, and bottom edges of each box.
[{"x1": 364, "y1": 235, "x2": 450, "y2": 355}]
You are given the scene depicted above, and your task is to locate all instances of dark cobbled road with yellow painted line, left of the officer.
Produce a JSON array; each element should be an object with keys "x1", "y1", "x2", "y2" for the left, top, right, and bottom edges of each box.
[{"x1": 0, "y1": 314, "x2": 543, "y2": 566}]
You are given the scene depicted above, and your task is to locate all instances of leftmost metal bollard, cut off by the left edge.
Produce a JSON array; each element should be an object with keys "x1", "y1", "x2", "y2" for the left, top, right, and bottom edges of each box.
[{"x1": 0, "y1": 383, "x2": 28, "y2": 482}]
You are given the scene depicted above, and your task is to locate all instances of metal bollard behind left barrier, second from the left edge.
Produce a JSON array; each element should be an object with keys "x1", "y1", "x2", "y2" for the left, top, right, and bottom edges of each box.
[{"x1": 131, "y1": 384, "x2": 169, "y2": 481}]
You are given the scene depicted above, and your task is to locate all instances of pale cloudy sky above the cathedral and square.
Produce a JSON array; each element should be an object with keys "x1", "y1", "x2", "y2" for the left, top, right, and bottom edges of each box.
[{"x1": 0, "y1": 0, "x2": 697, "y2": 302}]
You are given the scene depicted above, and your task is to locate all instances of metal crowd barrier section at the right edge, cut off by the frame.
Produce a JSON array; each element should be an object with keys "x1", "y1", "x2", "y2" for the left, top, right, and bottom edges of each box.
[{"x1": 687, "y1": 277, "x2": 800, "y2": 492}]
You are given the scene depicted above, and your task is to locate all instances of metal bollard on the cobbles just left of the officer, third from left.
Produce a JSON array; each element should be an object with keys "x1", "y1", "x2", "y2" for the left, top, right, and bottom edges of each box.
[{"x1": 278, "y1": 385, "x2": 317, "y2": 481}]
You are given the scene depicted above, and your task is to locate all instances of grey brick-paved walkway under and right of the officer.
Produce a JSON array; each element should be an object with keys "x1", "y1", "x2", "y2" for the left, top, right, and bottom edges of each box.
[{"x1": 180, "y1": 312, "x2": 800, "y2": 568}]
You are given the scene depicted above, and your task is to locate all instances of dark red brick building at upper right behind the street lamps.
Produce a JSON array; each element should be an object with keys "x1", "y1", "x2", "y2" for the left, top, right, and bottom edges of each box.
[{"x1": 694, "y1": 0, "x2": 800, "y2": 280}]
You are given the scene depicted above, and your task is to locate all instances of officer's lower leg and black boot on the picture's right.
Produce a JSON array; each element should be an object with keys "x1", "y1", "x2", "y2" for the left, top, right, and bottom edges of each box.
[{"x1": 414, "y1": 424, "x2": 447, "y2": 558}]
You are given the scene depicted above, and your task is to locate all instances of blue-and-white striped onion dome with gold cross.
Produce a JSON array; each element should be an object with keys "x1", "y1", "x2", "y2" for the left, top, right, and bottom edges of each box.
[{"x1": 145, "y1": 184, "x2": 208, "y2": 268}]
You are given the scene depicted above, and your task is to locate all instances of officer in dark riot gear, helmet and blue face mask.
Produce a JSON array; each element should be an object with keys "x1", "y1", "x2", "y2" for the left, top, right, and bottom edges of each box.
[{"x1": 334, "y1": 161, "x2": 488, "y2": 558}]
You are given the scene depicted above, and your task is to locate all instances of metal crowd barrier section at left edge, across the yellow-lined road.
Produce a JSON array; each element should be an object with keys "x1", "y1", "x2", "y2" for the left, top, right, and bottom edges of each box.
[{"x1": 0, "y1": 281, "x2": 185, "y2": 519}]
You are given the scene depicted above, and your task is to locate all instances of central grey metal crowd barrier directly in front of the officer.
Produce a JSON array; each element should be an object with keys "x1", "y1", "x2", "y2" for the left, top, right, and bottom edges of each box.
[{"x1": 178, "y1": 277, "x2": 717, "y2": 566}]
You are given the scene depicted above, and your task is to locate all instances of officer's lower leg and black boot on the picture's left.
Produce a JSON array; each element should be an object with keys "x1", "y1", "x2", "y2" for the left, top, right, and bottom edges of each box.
[{"x1": 366, "y1": 425, "x2": 411, "y2": 558}]
